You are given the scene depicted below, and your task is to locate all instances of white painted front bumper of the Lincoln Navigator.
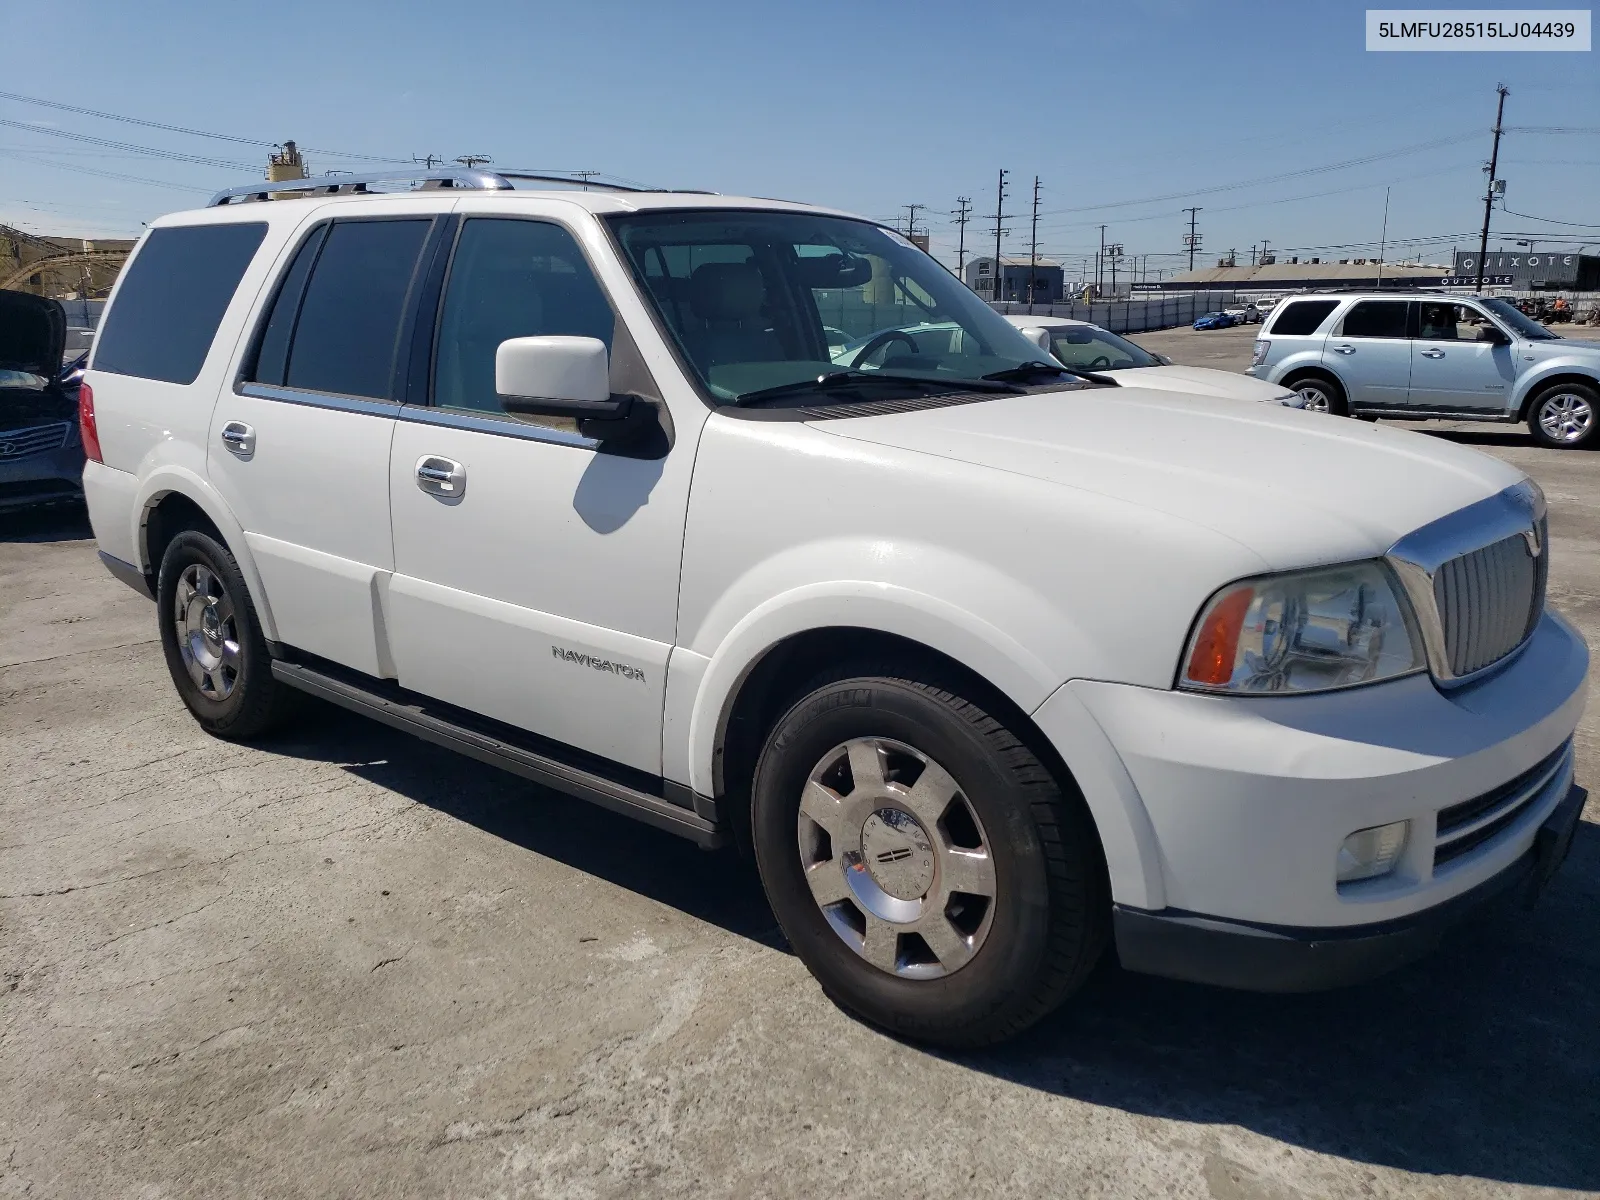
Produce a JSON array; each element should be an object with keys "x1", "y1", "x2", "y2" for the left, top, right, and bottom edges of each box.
[{"x1": 1034, "y1": 613, "x2": 1589, "y2": 985}]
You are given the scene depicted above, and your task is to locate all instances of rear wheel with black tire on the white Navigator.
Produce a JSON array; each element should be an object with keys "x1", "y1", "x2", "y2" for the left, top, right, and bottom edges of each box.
[{"x1": 155, "y1": 530, "x2": 298, "y2": 741}]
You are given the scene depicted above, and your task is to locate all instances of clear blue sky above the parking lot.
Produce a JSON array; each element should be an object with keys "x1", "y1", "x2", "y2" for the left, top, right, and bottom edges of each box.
[{"x1": 0, "y1": 0, "x2": 1600, "y2": 269}]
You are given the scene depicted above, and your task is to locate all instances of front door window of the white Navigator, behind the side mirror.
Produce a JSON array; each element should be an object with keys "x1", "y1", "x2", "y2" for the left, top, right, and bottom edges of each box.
[{"x1": 434, "y1": 218, "x2": 616, "y2": 413}]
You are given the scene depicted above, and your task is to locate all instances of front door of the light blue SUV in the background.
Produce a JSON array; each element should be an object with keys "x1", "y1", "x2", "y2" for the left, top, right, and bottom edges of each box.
[{"x1": 1411, "y1": 301, "x2": 1517, "y2": 413}]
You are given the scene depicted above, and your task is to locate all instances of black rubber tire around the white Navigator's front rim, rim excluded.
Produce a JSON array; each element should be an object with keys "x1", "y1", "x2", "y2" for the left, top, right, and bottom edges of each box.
[{"x1": 752, "y1": 678, "x2": 1050, "y2": 1029}]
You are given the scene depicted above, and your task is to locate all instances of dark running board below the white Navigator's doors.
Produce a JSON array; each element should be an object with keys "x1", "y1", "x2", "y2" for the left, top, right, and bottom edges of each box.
[{"x1": 272, "y1": 659, "x2": 726, "y2": 850}]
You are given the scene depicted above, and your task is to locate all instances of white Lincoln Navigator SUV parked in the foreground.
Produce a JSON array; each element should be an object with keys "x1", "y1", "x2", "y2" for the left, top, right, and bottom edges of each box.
[{"x1": 80, "y1": 171, "x2": 1589, "y2": 1045}]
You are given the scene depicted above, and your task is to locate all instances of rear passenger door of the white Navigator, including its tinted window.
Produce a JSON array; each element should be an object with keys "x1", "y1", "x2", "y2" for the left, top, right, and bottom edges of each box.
[{"x1": 208, "y1": 200, "x2": 448, "y2": 677}]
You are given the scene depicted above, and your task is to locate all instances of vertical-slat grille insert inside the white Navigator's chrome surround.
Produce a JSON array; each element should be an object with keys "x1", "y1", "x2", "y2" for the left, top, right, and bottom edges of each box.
[{"x1": 1434, "y1": 520, "x2": 1549, "y2": 678}]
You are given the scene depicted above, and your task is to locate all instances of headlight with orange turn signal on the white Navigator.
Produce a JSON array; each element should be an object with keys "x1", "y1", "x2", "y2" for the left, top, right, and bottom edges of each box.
[{"x1": 1178, "y1": 562, "x2": 1424, "y2": 694}]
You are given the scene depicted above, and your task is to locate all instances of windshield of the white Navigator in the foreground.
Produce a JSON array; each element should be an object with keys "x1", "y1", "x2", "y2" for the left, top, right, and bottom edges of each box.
[{"x1": 610, "y1": 210, "x2": 1043, "y2": 403}]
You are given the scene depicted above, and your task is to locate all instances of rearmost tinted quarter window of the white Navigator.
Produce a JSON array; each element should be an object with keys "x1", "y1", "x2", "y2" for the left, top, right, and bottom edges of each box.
[{"x1": 94, "y1": 222, "x2": 267, "y2": 384}]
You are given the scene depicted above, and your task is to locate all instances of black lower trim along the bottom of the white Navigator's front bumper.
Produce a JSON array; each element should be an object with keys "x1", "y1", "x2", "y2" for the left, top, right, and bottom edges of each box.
[{"x1": 1112, "y1": 784, "x2": 1589, "y2": 992}]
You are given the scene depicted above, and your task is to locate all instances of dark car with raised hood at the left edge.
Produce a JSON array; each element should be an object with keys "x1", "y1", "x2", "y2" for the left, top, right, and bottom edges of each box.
[{"x1": 0, "y1": 291, "x2": 83, "y2": 512}]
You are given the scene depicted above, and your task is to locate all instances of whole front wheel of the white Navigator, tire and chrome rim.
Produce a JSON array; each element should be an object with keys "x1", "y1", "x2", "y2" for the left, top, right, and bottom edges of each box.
[{"x1": 752, "y1": 666, "x2": 1109, "y2": 1046}]
